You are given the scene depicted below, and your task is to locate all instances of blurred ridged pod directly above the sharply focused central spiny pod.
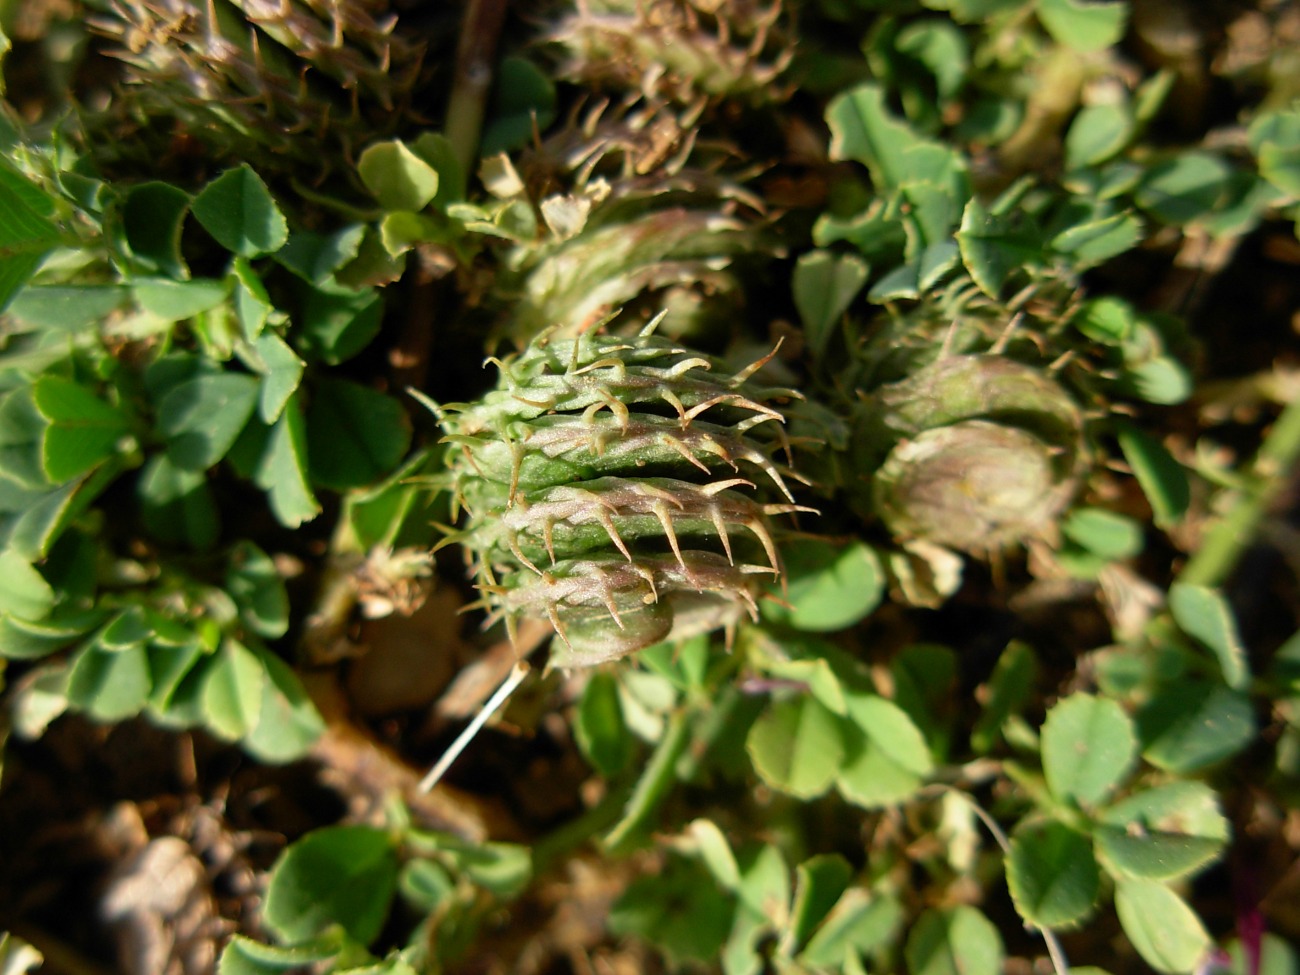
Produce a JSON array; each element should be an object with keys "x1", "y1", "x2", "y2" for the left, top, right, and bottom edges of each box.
[{"x1": 497, "y1": 101, "x2": 775, "y2": 345}]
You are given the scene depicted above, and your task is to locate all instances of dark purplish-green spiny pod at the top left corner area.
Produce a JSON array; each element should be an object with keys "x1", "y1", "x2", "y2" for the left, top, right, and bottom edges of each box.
[{"x1": 91, "y1": 0, "x2": 423, "y2": 177}]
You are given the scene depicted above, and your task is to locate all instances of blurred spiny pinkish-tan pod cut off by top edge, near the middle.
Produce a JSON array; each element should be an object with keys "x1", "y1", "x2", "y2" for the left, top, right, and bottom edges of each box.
[{"x1": 547, "y1": 0, "x2": 793, "y2": 104}]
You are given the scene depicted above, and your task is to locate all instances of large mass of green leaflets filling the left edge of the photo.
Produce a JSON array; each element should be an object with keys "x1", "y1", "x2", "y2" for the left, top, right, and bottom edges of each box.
[{"x1": 0, "y1": 135, "x2": 410, "y2": 761}]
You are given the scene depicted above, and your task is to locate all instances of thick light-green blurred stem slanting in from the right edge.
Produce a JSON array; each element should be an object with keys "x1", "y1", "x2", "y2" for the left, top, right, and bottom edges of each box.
[{"x1": 1178, "y1": 398, "x2": 1300, "y2": 586}]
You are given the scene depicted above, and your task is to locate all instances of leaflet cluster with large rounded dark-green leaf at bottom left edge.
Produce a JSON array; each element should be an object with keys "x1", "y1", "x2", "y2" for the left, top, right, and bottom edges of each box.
[{"x1": 217, "y1": 810, "x2": 532, "y2": 975}]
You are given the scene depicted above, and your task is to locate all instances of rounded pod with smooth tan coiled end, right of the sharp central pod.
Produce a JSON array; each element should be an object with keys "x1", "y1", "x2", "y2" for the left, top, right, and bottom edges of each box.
[{"x1": 858, "y1": 354, "x2": 1083, "y2": 551}]
